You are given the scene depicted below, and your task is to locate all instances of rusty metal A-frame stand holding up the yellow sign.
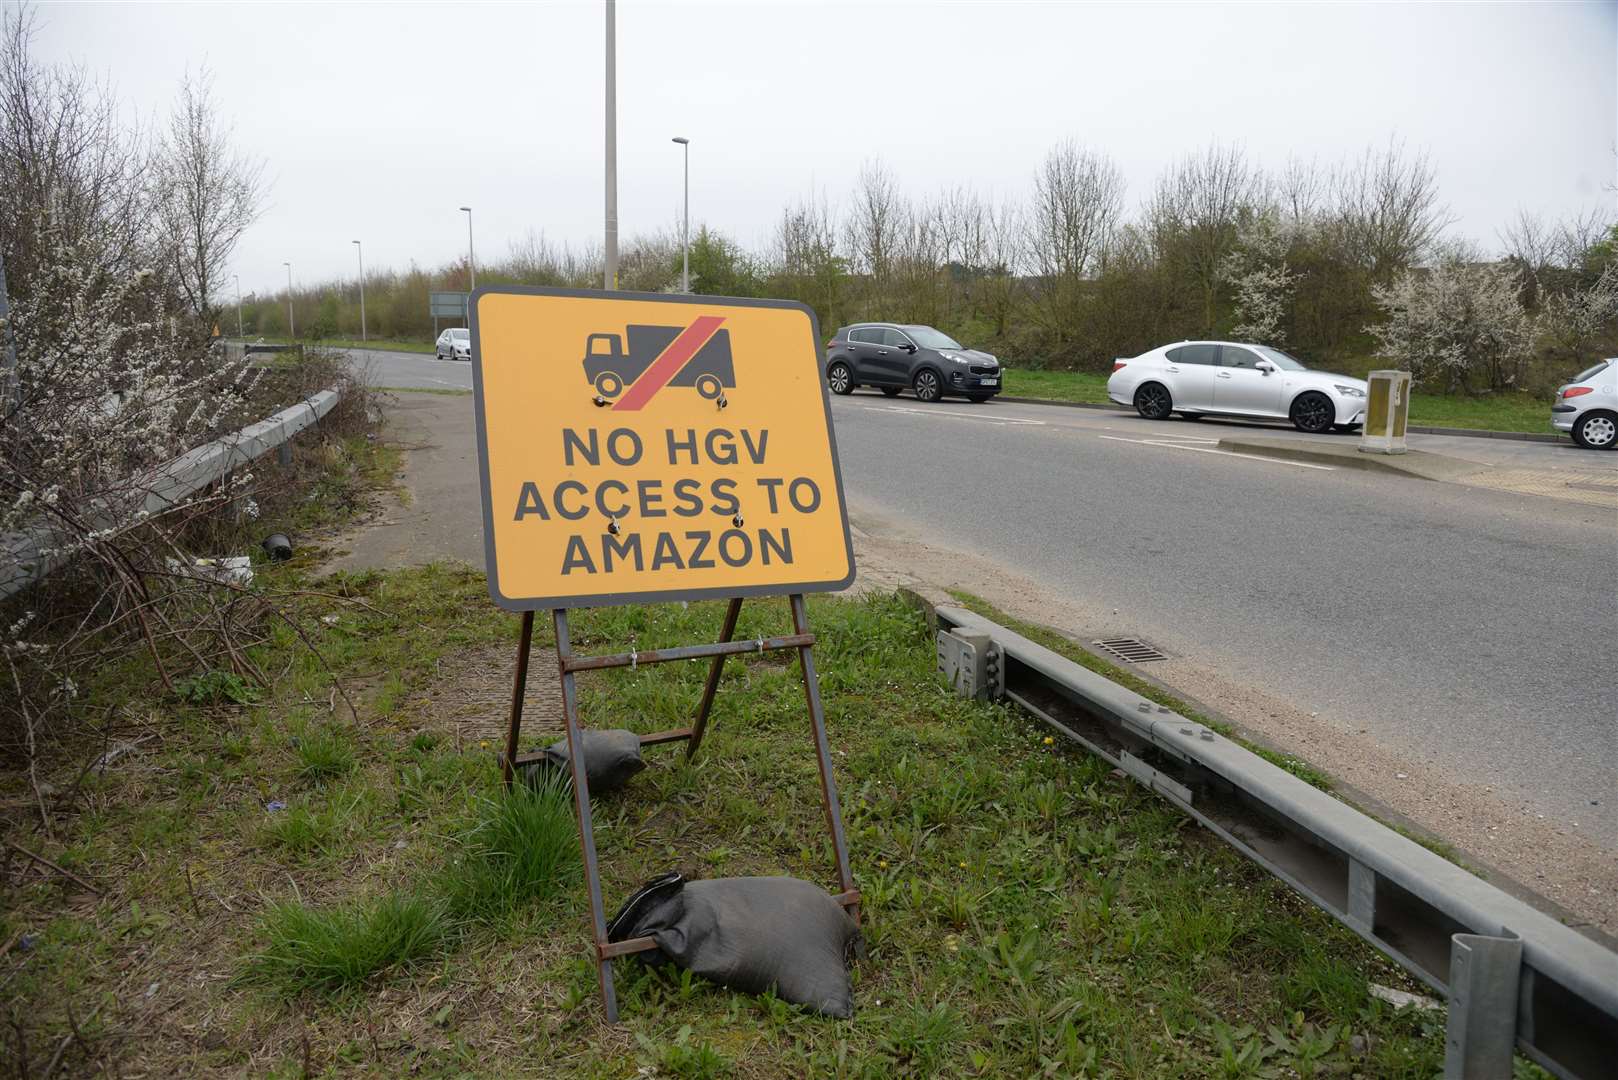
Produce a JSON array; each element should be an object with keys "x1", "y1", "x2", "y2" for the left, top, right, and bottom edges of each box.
[{"x1": 502, "y1": 593, "x2": 859, "y2": 1023}]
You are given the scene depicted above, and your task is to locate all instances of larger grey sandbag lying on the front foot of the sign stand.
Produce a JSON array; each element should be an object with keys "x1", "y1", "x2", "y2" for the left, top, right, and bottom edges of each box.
[{"x1": 607, "y1": 873, "x2": 859, "y2": 1018}]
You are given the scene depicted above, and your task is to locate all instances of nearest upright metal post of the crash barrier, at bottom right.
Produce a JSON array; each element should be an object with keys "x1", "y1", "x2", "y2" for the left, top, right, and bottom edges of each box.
[{"x1": 1443, "y1": 928, "x2": 1523, "y2": 1080}]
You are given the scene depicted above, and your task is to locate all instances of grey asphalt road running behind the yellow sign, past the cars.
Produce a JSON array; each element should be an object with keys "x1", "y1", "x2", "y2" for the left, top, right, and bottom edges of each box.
[{"x1": 354, "y1": 353, "x2": 1618, "y2": 845}]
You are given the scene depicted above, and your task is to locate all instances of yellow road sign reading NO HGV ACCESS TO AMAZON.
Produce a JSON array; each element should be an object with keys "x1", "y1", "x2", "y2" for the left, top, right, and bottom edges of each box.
[{"x1": 471, "y1": 287, "x2": 854, "y2": 610}]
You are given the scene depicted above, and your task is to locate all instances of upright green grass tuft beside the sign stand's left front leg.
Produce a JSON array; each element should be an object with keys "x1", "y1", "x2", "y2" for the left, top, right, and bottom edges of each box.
[{"x1": 442, "y1": 776, "x2": 579, "y2": 921}]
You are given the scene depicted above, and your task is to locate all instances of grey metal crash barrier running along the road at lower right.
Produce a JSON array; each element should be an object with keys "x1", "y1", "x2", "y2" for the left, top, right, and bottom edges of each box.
[{"x1": 935, "y1": 607, "x2": 1618, "y2": 1078}]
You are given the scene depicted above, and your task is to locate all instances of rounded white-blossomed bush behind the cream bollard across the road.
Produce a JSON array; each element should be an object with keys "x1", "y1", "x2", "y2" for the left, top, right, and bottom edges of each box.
[{"x1": 1366, "y1": 256, "x2": 1535, "y2": 393}]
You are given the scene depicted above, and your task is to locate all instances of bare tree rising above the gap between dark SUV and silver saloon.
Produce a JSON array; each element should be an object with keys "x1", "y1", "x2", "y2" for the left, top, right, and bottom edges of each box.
[{"x1": 1024, "y1": 139, "x2": 1125, "y2": 343}]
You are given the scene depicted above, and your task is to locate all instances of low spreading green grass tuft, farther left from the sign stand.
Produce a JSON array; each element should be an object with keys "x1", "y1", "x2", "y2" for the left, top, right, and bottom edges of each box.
[{"x1": 243, "y1": 892, "x2": 448, "y2": 994}]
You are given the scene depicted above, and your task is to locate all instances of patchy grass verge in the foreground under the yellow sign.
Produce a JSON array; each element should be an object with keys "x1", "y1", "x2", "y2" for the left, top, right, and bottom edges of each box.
[{"x1": 0, "y1": 563, "x2": 1482, "y2": 1077}]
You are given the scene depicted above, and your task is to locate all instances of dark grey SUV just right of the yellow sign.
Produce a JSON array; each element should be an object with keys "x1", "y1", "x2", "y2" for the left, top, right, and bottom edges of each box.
[{"x1": 825, "y1": 322, "x2": 1002, "y2": 402}]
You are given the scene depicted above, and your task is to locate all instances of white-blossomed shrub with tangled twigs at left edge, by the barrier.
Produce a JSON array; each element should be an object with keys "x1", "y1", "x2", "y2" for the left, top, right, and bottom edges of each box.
[{"x1": 0, "y1": 228, "x2": 252, "y2": 803}]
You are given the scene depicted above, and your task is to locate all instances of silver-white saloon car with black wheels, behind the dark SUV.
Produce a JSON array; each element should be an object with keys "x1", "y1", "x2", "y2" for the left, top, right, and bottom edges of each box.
[{"x1": 1107, "y1": 342, "x2": 1366, "y2": 432}]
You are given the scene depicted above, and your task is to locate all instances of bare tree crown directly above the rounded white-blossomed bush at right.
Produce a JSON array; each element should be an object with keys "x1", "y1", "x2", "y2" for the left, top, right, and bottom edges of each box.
[{"x1": 1333, "y1": 139, "x2": 1453, "y2": 280}]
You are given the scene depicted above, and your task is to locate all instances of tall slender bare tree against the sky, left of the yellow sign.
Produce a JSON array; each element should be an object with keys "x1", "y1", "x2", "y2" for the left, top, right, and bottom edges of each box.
[{"x1": 152, "y1": 70, "x2": 264, "y2": 322}]
